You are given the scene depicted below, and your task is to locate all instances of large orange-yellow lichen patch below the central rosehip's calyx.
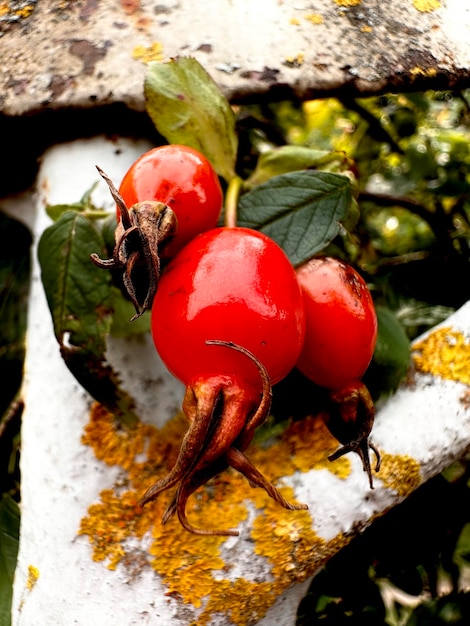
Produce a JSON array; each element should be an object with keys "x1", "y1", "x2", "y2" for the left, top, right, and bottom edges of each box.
[{"x1": 79, "y1": 404, "x2": 350, "y2": 626}]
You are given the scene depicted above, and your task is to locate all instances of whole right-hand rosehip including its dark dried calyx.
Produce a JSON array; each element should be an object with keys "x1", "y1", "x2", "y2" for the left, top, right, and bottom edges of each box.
[{"x1": 297, "y1": 257, "x2": 380, "y2": 487}]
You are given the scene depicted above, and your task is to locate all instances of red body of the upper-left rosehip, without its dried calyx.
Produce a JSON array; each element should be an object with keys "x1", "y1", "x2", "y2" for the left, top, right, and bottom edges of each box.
[{"x1": 118, "y1": 144, "x2": 223, "y2": 258}]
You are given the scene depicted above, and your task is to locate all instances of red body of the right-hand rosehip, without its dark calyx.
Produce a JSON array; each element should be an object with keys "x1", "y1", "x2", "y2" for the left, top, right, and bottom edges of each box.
[{"x1": 297, "y1": 257, "x2": 377, "y2": 390}]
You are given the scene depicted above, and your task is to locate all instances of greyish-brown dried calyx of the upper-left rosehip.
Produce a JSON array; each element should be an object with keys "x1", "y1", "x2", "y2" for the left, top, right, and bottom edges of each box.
[{"x1": 91, "y1": 166, "x2": 178, "y2": 321}]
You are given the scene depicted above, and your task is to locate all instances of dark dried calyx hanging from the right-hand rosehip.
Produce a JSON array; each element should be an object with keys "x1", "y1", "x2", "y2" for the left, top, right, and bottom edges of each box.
[{"x1": 326, "y1": 380, "x2": 381, "y2": 489}]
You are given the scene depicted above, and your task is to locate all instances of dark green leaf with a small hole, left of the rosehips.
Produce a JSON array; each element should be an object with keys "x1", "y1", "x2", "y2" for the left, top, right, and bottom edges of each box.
[{"x1": 38, "y1": 211, "x2": 138, "y2": 424}]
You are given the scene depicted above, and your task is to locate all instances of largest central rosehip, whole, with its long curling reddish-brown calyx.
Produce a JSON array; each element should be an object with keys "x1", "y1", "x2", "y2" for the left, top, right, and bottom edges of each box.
[{"x1": 141, "y1": 227, "x2": 305, "y2": 534}]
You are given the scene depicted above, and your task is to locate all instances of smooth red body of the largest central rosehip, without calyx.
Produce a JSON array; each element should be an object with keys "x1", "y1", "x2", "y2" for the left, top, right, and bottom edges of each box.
[{"x1": 152, "y1": 228, "x2": 304, "y2": 386}]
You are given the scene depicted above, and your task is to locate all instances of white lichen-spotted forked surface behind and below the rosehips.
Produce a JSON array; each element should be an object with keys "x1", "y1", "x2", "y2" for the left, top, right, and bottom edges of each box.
[{"x1": 6, "y1": 137, "x2": 470, "y2": 626}]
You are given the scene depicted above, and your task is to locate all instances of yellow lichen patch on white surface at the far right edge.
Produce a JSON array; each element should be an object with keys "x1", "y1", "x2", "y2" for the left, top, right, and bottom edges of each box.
[{"x1": 413, "y1": 327, "x2": 470, "y2": 385}]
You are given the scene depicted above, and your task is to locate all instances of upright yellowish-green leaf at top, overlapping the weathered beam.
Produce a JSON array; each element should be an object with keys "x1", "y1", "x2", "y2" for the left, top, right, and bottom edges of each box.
[{"x1": 144, "y1": 57, "x2": 238, "y2": 181}]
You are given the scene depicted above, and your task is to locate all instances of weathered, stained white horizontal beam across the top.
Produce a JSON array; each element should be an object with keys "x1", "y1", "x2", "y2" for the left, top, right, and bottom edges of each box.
[{"x1": 0, "y1": 0, "x2": 470, "y2": 115}]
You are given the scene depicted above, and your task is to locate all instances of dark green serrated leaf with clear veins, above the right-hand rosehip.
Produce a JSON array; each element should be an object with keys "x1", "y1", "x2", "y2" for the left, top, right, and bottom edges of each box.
[{"x1": 237, "y1": 171, "x2": 351, "y2": 265}]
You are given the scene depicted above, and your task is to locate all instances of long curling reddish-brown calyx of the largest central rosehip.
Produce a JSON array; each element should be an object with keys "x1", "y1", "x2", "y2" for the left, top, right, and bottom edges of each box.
[{"x1": 139, "y1": 340, "x2": 308, "y2": 536}]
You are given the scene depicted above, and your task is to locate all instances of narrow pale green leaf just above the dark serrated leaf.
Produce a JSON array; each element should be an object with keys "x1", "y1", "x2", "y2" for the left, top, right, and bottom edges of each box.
[{"x1": 245, "y1": 145, "x2": 347, "y2": 188}]
